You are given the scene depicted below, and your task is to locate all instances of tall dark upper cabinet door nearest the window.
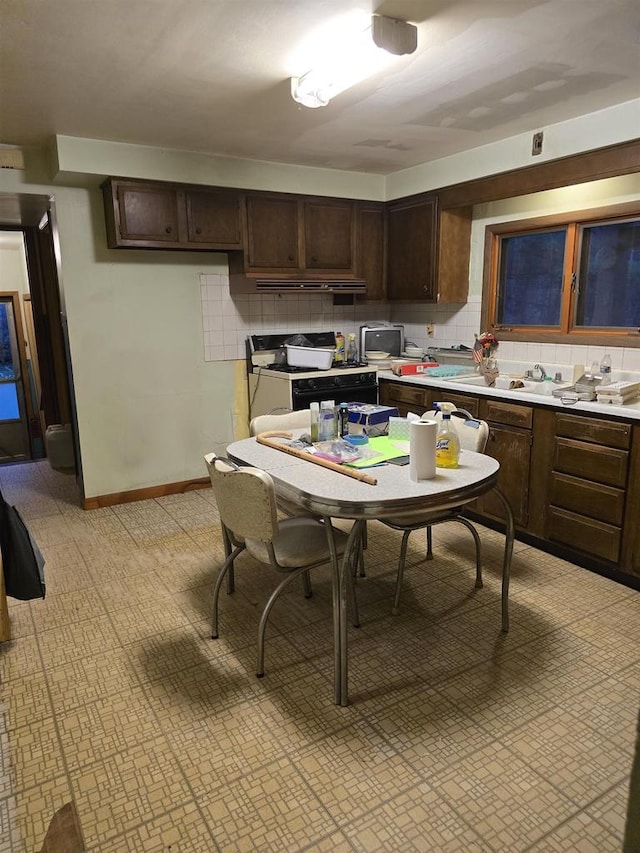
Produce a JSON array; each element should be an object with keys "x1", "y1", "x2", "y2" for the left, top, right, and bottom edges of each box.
[{"x1": 387, "y1": 197, "x2": 437, "y2": 302}]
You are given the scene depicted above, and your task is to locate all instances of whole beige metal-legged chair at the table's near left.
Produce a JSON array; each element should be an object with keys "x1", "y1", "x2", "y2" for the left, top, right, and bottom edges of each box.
[{"x1": 205, "y1": 453, "x2": 359, "y2": 678}]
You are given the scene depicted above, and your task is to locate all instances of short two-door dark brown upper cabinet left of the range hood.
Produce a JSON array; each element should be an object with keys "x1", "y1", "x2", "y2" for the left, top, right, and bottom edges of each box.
[{"x1": 102, "y1": 178, "x2": 242, "y2": 251}]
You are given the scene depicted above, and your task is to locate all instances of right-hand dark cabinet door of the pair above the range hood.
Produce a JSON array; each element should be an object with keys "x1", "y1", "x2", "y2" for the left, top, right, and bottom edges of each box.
[{"x1": 303, "y1": 199, "x2": 355, "y2": 275}]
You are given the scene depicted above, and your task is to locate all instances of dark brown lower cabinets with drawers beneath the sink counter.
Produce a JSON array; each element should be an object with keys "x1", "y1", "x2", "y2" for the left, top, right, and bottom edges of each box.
[{"x1": 380, "y1": 380, "x2": 640, "y2": 586}]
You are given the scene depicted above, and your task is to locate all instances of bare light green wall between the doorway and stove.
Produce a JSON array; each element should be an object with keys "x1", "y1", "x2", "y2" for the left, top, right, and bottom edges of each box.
[{"x1": 0, "y1": 158, "x2": 243, "y2": 497}]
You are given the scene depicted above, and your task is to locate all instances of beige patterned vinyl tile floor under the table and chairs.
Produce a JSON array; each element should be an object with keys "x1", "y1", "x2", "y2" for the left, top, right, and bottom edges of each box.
[{"x1": 0, "y1": 462, "x2": 640, "y2": 853}]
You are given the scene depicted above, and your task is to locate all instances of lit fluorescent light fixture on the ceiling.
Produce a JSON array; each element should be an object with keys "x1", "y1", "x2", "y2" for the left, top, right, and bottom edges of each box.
[{"x1": 291, "y1": 15, "x2": 418, "y2": 109}]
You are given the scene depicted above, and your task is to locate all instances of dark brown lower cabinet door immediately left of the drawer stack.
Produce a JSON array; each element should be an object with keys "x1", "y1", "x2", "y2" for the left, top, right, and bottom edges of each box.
[{"x1": 474, "y1": 424, "x2": 531, "y2": 527}]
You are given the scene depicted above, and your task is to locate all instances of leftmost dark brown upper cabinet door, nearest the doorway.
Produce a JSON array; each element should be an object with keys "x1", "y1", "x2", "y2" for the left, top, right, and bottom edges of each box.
[{"x1": 116, "y1": 184, "x2": 179, "y2": 247}]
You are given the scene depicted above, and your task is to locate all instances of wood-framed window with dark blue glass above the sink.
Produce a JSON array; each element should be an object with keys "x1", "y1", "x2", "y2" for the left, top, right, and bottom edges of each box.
[{"x1": 483, "y1": 214, "x2": 640, "y2": 345}]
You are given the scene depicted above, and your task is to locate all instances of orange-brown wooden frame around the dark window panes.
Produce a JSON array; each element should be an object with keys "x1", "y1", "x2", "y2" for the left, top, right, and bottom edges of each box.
[{"x1": 481, "y1": 201, "x2": 640, "y2": 348}]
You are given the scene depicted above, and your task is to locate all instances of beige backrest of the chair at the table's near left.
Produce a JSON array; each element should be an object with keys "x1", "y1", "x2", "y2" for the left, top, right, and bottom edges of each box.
[{"x1": 204, "y1": 453, "x2": 278, "y2": 542}]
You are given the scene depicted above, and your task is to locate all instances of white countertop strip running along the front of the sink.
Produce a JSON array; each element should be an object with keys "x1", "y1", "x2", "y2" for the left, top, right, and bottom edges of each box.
[{"x1": 378, "y1": 370, "x2": 640, "y2": 421}]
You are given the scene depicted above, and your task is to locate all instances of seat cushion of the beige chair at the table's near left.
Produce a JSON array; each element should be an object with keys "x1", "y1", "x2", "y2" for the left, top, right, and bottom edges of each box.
[{"x1": 246, "y1": 516, "x2": 347, "y2": 568}]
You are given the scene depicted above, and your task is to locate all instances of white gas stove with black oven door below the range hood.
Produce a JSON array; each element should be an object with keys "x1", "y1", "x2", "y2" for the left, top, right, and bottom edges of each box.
[{"x1": 247, "y1": 332, "x2": 378, "y2": 418}]
